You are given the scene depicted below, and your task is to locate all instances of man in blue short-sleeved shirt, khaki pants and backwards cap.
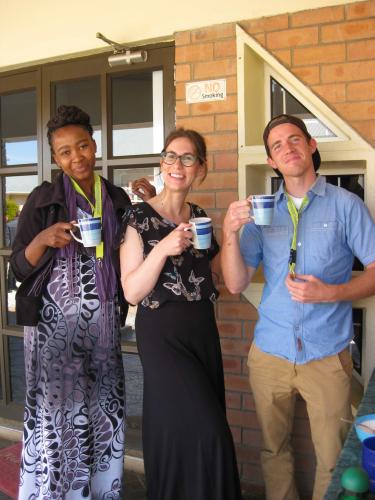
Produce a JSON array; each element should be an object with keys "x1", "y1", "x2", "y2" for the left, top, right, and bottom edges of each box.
[{"x1": 222, "y1": 115, "x2": 375, "y2": 500}]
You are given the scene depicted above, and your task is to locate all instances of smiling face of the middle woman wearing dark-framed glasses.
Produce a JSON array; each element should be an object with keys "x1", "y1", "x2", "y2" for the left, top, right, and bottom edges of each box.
[{"x1": 160, "y1": 137, "x2": 204, "y2": 191}]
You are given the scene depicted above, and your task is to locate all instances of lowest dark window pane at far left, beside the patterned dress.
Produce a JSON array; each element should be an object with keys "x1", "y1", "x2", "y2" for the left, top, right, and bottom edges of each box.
[{"x1": 8, "y1": 337, "x2": 26, "y2": 405}]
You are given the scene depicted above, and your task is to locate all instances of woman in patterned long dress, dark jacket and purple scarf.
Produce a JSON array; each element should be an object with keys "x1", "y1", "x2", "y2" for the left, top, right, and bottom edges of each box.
[{"x1": 11, "y1": 106, "x2": 154, "y2": 500}]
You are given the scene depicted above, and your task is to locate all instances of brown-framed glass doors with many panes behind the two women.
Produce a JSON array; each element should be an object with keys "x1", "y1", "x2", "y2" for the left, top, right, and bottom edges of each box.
[{"x1": 0, "y1": 43, "x2": 175, "y2": 426}]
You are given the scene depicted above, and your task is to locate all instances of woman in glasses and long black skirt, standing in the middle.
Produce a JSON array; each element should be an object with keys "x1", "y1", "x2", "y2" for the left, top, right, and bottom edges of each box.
[{"x1": 120, "y1": 129, "x2": 241, "y2": 500}]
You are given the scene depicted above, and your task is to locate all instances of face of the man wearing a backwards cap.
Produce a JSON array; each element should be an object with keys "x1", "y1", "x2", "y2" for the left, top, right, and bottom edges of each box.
[{"x1": 267, "y1": 123, "x2": 316, "y2": 182}]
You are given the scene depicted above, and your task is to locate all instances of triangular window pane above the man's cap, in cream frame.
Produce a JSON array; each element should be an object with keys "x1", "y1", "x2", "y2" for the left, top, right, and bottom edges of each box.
[{"x1": 271, "y1": 78, "x2": 336, "y2": 138}]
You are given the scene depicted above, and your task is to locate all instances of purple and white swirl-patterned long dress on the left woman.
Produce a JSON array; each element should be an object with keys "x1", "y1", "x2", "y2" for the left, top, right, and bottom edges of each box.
[{"x1": 19, "y1": 254, "x2": 125, "y2": 500}]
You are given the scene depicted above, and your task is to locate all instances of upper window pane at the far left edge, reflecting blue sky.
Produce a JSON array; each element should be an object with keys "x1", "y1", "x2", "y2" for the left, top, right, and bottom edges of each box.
[{"x1": 0, "y1": 90, "x2": 38, "y2": 166}]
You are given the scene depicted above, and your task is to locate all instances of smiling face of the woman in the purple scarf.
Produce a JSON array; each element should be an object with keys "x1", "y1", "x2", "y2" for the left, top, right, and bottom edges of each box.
[{"x1": 52, "y1": 125, "x2": 96, "y2": 193}]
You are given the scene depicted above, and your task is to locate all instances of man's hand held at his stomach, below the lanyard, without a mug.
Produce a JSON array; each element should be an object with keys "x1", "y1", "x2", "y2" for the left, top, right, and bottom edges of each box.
[{"x1": 285, "y1": 274, "x2": 336, "y2": 303}]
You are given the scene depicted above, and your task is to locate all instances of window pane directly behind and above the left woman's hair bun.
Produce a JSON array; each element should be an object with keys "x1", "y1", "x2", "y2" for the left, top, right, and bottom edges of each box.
[{"x1": 55, "y1": 77, "x2": 102, "y2": 158}]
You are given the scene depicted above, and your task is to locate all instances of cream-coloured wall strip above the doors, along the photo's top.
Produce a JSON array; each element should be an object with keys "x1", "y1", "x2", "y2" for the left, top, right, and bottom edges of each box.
[{"x1": 0, "y1": 0, "x2": 354, "y2": 71}]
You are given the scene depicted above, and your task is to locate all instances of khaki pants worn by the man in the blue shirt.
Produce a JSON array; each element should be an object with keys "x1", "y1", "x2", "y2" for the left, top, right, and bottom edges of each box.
[{"x1": 248, "y1": 343, "x2": 353, "y2": 500}]
